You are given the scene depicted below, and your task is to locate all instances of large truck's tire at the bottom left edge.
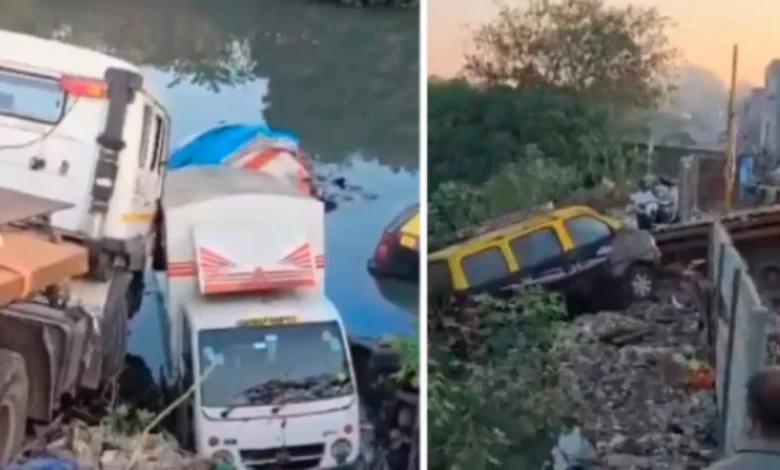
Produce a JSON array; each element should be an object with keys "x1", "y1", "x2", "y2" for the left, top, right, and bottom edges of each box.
[{"x1": 0, "y1": 349, "x2": 29, "y2": 468}]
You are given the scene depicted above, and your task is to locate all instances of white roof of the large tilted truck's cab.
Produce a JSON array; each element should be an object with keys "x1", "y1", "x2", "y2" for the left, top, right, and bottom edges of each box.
[{"x1": 0, "y1": 30, "x2": 161, "y2": 102}]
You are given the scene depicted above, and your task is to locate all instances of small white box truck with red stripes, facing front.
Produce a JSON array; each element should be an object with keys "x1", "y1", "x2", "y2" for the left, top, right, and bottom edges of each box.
[{"x1": 155, "y1": 167, "x2": 360, "y2": 469}]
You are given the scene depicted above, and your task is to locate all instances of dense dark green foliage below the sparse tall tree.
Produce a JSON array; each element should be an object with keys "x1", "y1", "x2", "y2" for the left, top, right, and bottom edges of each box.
[{"x1": 428, "y1": 80, "x2": 613, "y2": 190}]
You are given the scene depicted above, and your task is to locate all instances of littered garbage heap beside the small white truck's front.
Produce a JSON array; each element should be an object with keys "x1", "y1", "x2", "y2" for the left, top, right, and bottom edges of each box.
[{"x1": 3, "y1": 422, "x2": 222, "y2": 470}]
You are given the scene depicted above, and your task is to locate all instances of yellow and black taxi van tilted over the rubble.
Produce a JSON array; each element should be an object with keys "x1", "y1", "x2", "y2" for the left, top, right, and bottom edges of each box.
[{"x1": 428, "y1": 206, "x2": 660, "y2": 311}]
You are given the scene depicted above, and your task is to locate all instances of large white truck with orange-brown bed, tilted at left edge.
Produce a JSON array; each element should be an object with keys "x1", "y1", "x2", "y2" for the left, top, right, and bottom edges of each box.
[{"x1": 0, "y1": 30, "x2": 170, "y2": 465}]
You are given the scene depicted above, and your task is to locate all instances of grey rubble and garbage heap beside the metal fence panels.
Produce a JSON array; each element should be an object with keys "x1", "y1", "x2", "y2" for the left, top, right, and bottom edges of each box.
[{"x1": 565, "y1": 284, "x2": 716, "y2": 470}]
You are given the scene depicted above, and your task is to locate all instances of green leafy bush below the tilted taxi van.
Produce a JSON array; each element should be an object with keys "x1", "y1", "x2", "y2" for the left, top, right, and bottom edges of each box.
[{"x1": 428, "y1": 289, "x2": 571, "y2": 470}]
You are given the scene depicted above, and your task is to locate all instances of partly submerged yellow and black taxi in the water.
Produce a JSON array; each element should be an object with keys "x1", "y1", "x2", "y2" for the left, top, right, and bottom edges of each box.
[{"x1": 368, "y1": 204, "x2": 420, "y2": 282}]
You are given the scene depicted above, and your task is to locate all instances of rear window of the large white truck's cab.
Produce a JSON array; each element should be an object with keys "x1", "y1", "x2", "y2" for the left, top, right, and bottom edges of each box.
[{"x1": 0, "y1": 69, "x2": 65, "y2": 124}]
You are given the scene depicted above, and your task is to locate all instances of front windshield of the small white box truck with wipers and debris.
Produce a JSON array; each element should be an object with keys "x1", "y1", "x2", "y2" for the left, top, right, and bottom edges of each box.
[{"x1": 198, "y1": 321, "x2": 354, "y2": 407}]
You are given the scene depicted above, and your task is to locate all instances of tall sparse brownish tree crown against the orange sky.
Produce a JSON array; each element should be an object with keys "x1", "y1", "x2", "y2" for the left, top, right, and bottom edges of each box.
[{"x1": 465, "y1": 0, "x2": 677, "y2": 108}]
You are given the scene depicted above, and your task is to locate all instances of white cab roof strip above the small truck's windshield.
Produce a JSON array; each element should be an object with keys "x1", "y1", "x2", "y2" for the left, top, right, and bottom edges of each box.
[{"x1": 185, "y1": 291, "x2": 341, "y2": 330}]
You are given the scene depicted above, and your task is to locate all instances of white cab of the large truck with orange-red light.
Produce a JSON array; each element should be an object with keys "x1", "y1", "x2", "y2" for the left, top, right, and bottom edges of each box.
[{"x1": 0, "y1": 30, "x2": 170, "y2": 315}]
